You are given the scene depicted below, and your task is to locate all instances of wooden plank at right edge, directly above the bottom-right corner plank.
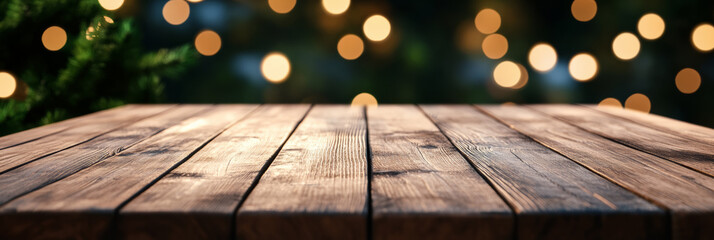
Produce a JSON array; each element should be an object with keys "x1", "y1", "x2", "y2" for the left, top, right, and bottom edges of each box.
[{"x1": 532, "y1": 105, "x2": 714, "y2": 176}]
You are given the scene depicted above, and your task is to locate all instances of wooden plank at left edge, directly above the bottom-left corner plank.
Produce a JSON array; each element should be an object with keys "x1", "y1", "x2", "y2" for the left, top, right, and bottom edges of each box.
[{"x1": 0, "y1": 105, "x2": 209, "y2": 204}]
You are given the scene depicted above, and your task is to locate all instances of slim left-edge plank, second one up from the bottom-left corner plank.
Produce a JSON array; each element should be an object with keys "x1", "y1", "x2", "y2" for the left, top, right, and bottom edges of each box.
[{"x1": 0, "y1": 105, "x2": 173, "y2": 173}]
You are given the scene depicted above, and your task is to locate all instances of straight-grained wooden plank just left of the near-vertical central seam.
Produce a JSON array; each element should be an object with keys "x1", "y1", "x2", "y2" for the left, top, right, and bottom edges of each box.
[{"x1": 236, "y1": 105, "x2": 368, "y2": 239}]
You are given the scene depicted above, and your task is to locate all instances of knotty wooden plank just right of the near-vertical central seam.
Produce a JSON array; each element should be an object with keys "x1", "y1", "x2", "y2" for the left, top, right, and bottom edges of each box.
[{"x1": 367, "y1": 105, "x2": 513, "y2": 239}]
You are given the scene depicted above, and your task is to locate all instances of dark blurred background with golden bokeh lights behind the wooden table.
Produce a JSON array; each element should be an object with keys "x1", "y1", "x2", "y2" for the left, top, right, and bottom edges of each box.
[{"x1": 0, "y1": 0, "x2": 714, "y2": 135}]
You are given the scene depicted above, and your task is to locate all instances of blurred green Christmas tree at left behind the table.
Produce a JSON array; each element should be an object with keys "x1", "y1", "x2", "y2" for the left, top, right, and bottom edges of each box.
[{"x1": 0, "y1": 0, "x2": 197, "y2": 135}]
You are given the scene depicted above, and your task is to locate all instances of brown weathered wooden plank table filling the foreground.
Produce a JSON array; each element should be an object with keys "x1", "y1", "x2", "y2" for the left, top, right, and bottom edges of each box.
[{"x1": 0, "y1": 105, "x2": 714, "y2": 239}]
